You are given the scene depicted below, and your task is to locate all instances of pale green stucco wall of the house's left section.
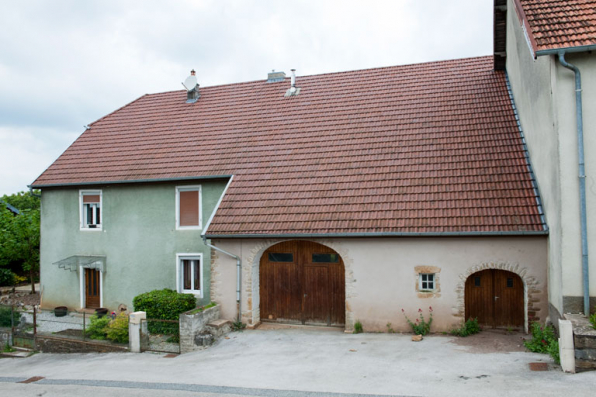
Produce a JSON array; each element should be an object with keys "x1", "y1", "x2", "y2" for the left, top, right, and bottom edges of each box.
[{"x1": 41, "y1": 180, "x2": 227, "y2": 310}]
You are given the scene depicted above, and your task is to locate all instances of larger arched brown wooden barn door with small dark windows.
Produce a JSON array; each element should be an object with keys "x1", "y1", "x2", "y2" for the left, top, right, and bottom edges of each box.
[{"x1": 259, "y1": 241, "x2": 345, "y2": 326}]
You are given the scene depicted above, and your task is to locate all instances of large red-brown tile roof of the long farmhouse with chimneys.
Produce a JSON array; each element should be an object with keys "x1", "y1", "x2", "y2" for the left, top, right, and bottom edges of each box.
[{"x1": 33, "y1": 57, "x2": 545, "y2": 236}]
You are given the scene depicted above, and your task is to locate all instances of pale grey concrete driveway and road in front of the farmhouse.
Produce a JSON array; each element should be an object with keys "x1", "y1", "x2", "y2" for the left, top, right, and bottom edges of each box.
[{"x1": 0, "y1": 328, "x2": 596, "y2": 397}]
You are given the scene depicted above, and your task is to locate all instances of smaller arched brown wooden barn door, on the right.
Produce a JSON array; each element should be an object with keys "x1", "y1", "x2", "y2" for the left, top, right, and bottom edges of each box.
[{"x1": 465, "y1": 269, "x2": 524, "y2": 328}]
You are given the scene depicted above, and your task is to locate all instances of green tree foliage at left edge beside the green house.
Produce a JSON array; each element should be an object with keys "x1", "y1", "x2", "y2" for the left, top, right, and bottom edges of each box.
[{"x1": 0, "y1": 192, "x2": 40, "y2": 292}]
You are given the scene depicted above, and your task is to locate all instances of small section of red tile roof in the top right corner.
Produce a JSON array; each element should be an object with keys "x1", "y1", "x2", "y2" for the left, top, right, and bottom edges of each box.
[{"x1": 516, "y1": 0, "x2": 596, "y2": 52}]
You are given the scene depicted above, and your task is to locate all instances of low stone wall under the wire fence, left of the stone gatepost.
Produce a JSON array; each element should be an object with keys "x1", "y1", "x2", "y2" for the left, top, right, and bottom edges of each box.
[{"x1": 35, "y1": 334, "x2": 128, "y2": 353}]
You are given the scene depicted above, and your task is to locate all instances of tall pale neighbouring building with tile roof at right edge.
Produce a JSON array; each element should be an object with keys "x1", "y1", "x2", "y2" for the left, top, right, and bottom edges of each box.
[{"x1": 498, "y1": 0, "x2": 596, "y2": 324}]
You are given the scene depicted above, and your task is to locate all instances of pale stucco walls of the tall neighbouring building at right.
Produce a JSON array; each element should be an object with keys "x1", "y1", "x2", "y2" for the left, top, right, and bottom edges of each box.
[{"x1": 507, "y1": 0, "x2": 596, "y2": 314}]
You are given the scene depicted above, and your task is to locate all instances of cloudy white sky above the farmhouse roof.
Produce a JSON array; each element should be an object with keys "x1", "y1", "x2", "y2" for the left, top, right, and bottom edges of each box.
[{"x1": 0, "y1": 0, "x2": 493, "y2": 196}]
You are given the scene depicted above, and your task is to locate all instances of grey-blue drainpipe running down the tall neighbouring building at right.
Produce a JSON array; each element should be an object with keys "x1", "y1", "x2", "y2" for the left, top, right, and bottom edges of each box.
[{"x1": 559, "y1": 51, "x2": 590, "y2": 316}]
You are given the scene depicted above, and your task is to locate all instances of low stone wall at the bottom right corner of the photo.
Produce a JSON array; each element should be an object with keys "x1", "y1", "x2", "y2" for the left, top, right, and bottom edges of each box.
[{"x1": 565, "y1": 314, "x2": 596, "y2": 372}]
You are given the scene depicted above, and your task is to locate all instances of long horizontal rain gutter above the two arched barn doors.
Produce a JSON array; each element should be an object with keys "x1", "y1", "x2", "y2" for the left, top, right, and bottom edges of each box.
[{"x1": 204, "y1": 230, "x2": 548, "y2": 239}]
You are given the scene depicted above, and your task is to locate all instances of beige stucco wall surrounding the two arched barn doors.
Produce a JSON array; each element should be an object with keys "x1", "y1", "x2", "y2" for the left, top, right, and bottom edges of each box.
[{"x1": 211, "y1": 237, "x2": 548, "y2": 332}]
